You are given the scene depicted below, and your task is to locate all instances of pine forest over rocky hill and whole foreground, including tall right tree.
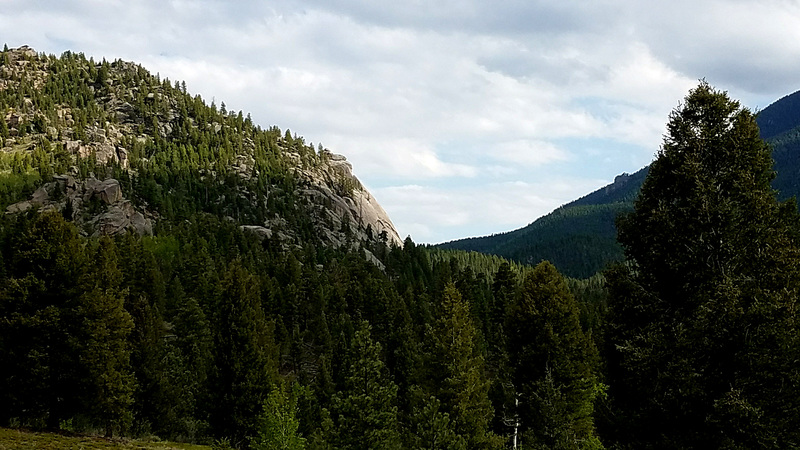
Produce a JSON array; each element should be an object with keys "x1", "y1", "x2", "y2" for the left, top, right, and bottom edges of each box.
[{"x1": 0, "y1": 47, "x2": 800, "y2": 449}]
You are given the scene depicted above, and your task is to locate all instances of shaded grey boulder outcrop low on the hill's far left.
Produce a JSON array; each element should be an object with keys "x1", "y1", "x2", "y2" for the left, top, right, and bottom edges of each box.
[{"x1": 6, "y1": 175, "x2": 153, "y2": 236}]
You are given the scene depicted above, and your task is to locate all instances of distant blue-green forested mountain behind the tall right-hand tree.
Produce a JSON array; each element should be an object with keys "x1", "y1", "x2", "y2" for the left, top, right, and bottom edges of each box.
[{"x1": 437, "y1": 91, "x2": 800, "y2": 278}]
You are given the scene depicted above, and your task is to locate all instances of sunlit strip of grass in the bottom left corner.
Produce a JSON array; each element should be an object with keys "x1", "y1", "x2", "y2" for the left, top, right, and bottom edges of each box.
[{"x1": 0, "y1": 428, "x2": 209, "y2": 450}]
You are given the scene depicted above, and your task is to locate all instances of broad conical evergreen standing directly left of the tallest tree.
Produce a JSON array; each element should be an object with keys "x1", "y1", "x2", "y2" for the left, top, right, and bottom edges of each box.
[{"x1": 507, "y1": 261, "x2": 602, "y2": 449}]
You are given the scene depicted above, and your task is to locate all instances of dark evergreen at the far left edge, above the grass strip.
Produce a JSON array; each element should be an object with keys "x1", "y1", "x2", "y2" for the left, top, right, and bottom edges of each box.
[{"x1": 0, "y1": 213, "x2": 86, "y2": 429}]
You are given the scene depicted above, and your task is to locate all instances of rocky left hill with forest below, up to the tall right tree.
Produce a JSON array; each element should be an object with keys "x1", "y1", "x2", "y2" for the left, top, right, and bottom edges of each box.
[{"x1": 0, "y1": 47, "x2": 604, "y2": 450}]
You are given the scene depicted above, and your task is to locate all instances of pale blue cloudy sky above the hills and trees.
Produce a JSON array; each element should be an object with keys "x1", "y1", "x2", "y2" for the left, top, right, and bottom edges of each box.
[{"x1": 0, "y1": 0, "x2": 800, "y2": 243}]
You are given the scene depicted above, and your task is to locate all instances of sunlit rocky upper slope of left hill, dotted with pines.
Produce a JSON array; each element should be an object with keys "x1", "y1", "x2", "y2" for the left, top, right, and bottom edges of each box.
[{"x1": 0, "y1": 47, "x2": 402, "y2": 253}]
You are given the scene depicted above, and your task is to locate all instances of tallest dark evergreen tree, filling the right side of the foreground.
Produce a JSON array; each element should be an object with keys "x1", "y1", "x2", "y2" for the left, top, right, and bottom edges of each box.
[{"x1": 608, "y1": 82, "x2": 800, "y2": 448}]
